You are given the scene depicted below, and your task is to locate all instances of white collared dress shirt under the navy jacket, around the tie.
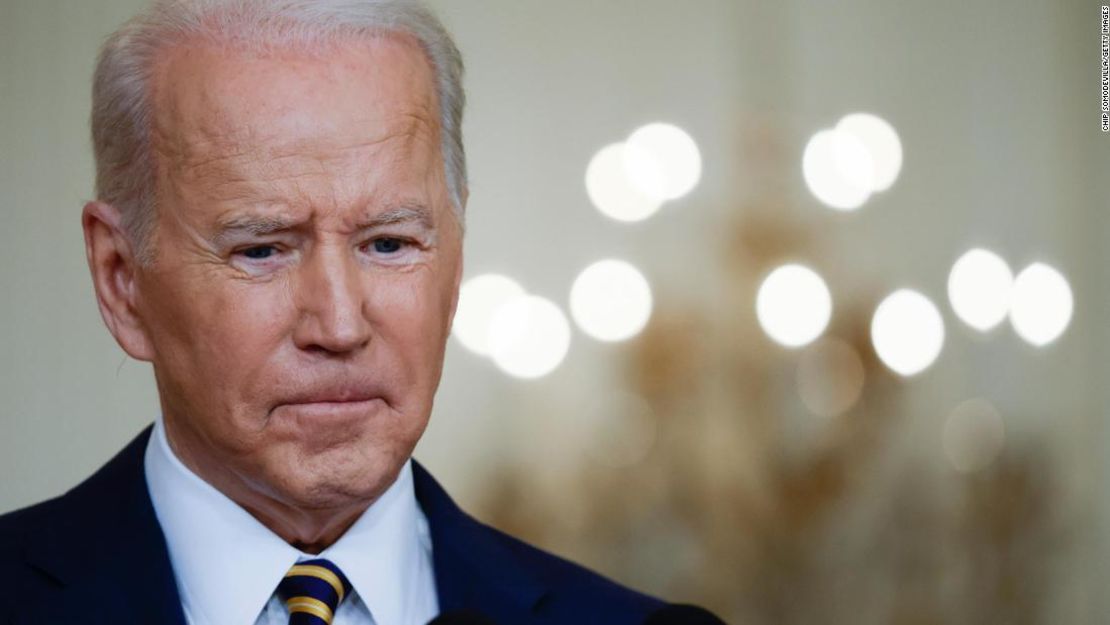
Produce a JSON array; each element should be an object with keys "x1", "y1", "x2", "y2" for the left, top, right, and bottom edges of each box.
[{"x1": 145, "y1": 416, "x2": 438, "y2": 625}]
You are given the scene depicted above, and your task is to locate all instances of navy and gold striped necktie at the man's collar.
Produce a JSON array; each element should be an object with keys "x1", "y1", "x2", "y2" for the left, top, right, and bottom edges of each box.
[{"x1": 278, "y1": 558, "x2": 351, "y2": 625}]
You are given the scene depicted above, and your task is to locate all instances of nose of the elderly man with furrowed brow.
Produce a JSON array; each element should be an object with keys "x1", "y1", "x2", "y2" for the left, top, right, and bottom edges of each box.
[{"x1": 293, "y1": 242, "x2": 371, "y2": 354}]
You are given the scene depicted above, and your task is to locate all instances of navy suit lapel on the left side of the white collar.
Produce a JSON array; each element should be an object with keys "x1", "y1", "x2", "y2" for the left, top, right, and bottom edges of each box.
[{"x1": 17, "y1": 427, "x2": 184, "y2": 625}]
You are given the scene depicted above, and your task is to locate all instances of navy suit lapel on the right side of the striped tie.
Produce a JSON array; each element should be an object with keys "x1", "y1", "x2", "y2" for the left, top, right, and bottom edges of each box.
[{"x1": 413, "y1": 461, "x2": 546, "y2": 625}]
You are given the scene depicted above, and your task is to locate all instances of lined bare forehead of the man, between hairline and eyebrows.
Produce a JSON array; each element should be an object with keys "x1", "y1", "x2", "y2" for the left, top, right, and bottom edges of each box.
[{"x1": 151, "y1": 34, "x2": 440, "y2": 195}]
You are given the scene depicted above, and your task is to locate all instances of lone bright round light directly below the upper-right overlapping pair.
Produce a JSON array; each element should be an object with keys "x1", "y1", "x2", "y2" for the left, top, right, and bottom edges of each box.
[{"x1": 756, "y1": 264, "x2": 833, "y2": 347}]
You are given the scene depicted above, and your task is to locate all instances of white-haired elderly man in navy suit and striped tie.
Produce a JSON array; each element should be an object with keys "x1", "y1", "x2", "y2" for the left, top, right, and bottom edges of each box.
[{"x1": 0, "y1": 0, "x2": 728, "y2": 625}]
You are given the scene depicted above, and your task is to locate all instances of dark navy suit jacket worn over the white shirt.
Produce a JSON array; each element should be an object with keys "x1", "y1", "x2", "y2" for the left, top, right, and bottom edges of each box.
[{"x1": 0, "y1": 427, "x2": 663, "y2": 625}]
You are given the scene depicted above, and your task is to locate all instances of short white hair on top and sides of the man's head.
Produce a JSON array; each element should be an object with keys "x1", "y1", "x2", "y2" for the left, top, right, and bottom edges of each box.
[{"x1": 91, "y1": 0, "x2": 467, "y2": 262}]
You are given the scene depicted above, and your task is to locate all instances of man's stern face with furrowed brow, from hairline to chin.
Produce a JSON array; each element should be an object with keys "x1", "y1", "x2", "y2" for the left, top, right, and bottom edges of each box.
[{"x1": 135, "y1": 37, "x2": 462, "y2": 510}]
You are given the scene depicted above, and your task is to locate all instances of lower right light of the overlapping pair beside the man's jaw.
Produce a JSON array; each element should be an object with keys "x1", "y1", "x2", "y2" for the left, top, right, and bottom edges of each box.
[{"x1": 490, "y1": 295, "x2": 571, "y2": 379}]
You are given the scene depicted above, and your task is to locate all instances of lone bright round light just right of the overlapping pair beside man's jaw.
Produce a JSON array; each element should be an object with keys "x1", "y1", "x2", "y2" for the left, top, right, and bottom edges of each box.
[{"x1": 571, "y1": 259, "x2": 652, "y2": 341}]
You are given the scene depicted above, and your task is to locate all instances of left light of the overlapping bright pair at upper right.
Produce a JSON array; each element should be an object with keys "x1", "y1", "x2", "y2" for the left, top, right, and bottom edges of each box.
[{"x1": 801, "y1": 130, "x2": 875, "y2": 211}]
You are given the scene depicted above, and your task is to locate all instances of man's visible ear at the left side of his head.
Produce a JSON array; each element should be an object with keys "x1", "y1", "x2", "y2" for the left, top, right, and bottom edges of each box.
[{"x1": 81, "y1": 202, "x2": 153, "y2": 361}]
